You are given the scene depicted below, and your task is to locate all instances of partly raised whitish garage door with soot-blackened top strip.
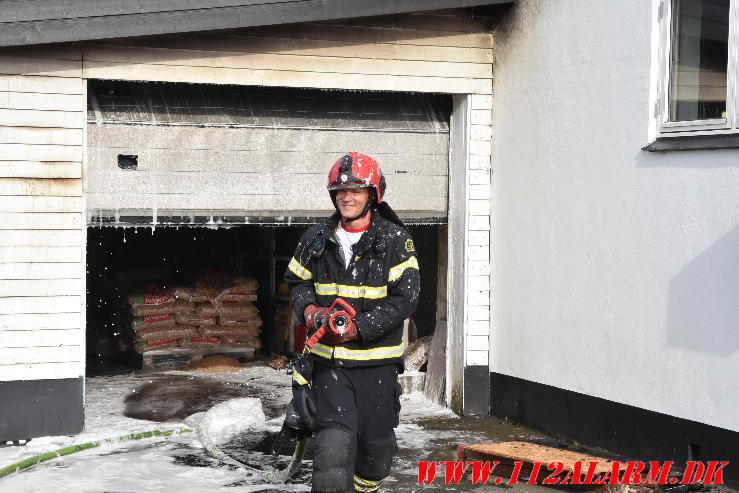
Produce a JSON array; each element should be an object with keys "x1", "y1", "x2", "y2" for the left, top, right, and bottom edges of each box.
[{"x1": 87, "y1": 83, "x2": 449, "y2": 216}]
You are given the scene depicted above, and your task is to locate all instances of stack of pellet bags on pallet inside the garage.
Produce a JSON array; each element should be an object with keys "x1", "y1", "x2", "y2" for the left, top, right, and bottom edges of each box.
[{"x1": 120, "y1": 273, "x2": 262, "y2": 354}]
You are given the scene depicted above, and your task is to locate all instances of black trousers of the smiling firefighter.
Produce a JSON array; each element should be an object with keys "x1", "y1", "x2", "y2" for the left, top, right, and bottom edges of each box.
[{"x1": 312, "y1": 362, "x2": 401, "y2": 493}]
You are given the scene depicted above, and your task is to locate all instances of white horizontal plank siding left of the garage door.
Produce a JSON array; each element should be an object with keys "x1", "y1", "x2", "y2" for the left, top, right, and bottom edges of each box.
[{"x1": 0, "y1": 47, "x2": 86, "y2": 381}]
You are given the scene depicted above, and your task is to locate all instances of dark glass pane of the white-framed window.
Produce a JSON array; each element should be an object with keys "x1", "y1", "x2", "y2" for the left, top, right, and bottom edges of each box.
[{"x1": 669, "y1": 0, "x2": 730, "y2": 121}]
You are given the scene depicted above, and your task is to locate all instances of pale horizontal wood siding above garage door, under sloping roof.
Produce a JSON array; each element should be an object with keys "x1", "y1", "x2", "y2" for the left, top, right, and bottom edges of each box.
[{"x1": 83, "y1": 12, "x2": 492, "y2": 94}]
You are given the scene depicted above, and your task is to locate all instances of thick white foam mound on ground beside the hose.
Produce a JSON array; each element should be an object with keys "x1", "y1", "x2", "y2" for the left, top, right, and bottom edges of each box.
[{"x1": 200, "y1": 397, "x2": 266, "y2": 445}]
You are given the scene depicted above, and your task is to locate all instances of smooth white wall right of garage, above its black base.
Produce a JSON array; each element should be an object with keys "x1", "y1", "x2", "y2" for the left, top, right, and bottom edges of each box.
[{"x1": 490, "y1": 0, "x2": 739, "y2": 431}]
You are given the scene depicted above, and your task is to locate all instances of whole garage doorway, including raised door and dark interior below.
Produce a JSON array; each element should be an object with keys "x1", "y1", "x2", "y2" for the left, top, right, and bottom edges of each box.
[{"x1": 86, "y1": 81, "x2": 451, "y2": 374}]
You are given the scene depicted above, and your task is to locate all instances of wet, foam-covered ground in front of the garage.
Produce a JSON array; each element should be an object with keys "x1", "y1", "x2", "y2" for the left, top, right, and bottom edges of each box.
[{"x1": 0, "y1": 362, "x2": 568, "y2": 493}]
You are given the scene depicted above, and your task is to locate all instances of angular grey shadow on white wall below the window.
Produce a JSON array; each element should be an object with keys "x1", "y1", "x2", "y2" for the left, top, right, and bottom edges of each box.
[{"x1": 667, "y1": 226, "x2": 739, "y2": 356}]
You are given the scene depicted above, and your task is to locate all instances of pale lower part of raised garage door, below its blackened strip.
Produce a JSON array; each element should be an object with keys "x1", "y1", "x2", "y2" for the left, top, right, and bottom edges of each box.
[{"x1": 84, "y1": 124, "x2": 449, "y2": 213}]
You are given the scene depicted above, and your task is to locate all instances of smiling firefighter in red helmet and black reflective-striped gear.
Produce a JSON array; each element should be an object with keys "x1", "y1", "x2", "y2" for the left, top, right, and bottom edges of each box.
[{"x1": 285, "y1": 152, "x2": 420, "y2": 493}]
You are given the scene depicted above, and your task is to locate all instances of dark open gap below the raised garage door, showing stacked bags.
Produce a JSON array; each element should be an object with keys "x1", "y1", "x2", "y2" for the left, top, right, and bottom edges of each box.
[{"x1": 87, "y1": 225, "x2": 439, "y2": 373}]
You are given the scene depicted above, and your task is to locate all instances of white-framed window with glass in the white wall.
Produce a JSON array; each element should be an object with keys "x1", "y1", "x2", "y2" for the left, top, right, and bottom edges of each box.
[{"x1": 657, "y1": 0, "x2": 739, "y2": 136}]
